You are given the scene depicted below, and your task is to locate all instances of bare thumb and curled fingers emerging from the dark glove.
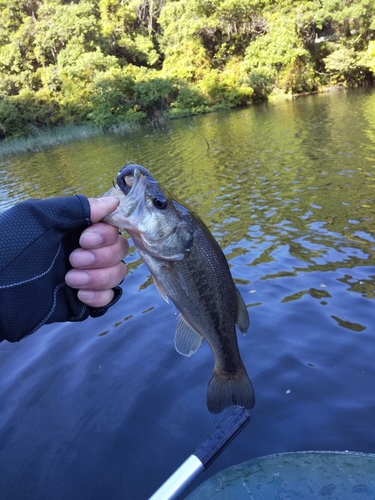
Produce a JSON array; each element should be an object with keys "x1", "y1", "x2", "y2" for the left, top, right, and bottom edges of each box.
[{"x1": 65, "y1": 196, "x2": 129, "y2": 307}]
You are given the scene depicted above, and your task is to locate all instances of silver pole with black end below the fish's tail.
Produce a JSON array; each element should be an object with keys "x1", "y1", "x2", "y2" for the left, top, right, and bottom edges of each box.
[{"x1": 149, "y1": 406, "x2": 250, "y2": 500}]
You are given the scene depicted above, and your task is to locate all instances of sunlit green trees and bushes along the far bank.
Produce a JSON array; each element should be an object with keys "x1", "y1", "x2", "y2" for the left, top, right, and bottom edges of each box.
[{"x1": 0, "y1": 0, "x2": 375, "y2": 138}]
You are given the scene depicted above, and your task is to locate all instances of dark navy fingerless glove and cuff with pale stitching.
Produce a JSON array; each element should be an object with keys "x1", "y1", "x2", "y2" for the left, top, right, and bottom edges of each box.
[{"x1": 0, "y1": 195, "x2": 121, "y2": 342}]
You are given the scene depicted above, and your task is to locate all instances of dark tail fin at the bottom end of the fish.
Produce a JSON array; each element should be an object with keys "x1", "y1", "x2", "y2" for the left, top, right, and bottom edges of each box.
[{"x1": 207, "y1": 367, "x2": 255, "y2": 413}]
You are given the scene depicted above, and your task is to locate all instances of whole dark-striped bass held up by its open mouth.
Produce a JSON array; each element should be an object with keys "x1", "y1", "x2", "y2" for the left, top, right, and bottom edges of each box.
[{"x1": 103, "y1": 164, "x2": 255, "y2": 414}]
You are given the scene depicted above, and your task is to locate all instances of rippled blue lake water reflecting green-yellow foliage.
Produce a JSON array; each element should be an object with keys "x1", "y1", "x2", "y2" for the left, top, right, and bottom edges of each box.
[{"x1": 0, "y1": 89, "x2": 375, "y2": 500}]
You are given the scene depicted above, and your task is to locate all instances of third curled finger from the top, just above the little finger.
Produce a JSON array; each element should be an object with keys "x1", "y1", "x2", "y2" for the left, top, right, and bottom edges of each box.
[{"x1": 65, "y1": 262, "x2": 127, "y2": 290}]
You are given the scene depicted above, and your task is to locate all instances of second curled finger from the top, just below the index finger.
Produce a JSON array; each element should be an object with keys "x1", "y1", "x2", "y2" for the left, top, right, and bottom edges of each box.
[{"x1": 69, "y1": 235, "x2": 129, "y2": 269}]
